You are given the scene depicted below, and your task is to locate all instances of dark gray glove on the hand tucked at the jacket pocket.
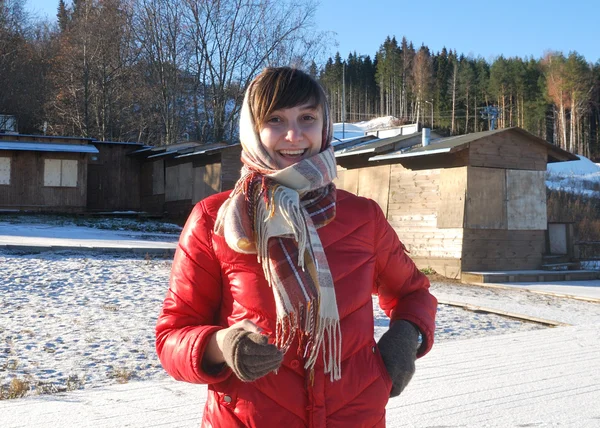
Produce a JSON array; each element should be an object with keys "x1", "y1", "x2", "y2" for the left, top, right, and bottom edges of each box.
[{"x1": 377, "y1": 320, "x2": 419, "y2": 397}]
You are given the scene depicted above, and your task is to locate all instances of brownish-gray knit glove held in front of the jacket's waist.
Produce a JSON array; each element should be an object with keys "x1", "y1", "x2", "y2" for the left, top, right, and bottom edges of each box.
[{"x1": 223, "y1": 328, "x2": 283, "y2": 382}]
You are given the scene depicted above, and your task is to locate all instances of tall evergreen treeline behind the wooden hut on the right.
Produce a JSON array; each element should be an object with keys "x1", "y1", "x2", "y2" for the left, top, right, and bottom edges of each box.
[{"x1": 320, "y1": 38, "x2": 600, "y2": 157}]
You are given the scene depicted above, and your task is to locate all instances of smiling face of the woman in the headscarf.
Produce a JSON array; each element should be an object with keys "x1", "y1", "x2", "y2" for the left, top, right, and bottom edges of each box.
[{"x1": 259, "y1": 104, "x2": 323, "y2": 169}]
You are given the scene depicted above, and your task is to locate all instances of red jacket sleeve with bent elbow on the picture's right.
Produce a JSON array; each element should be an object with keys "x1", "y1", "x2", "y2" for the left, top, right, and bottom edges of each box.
[{"x1": 373, "y1": 202, "x2": 437, "y2": 357}]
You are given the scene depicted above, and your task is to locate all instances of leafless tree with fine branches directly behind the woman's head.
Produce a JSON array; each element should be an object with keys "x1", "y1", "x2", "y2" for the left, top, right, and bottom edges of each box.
[{"x1": 184, "y1": 0, "x2": 323, "y2": 141}]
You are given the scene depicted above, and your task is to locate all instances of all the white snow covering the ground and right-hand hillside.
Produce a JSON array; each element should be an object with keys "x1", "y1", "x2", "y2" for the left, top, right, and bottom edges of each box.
[{"x1": 0, "y1": 146, "x2": 600, "y2": 428}]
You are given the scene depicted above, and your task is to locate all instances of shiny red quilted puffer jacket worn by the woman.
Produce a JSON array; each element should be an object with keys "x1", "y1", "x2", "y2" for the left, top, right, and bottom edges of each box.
[{"x1": 156, "y1": 190, "x2": 437, "y2": 428}]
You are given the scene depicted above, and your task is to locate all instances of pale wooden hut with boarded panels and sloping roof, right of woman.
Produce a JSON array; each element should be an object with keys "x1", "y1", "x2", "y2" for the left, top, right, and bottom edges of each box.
[{"x1": 337, "y1": 128, "x2": 577, "y2": 278}]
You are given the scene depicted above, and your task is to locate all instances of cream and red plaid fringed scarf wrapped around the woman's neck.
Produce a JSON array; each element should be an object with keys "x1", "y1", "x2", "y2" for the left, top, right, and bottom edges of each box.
[{"x1": 215, "y1": 93, "x2": 342, "y2": 381}]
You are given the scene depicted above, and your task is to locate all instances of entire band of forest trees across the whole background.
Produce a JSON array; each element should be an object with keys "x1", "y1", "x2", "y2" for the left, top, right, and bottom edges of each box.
[{"x1": 0, "y1": 0, "x2": 600, "y2": 159}]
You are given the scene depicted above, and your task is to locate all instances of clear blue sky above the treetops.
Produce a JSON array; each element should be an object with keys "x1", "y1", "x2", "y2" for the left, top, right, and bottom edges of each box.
[{"x1": 27, "y1": 0, "x2": 600, "y2": 62}]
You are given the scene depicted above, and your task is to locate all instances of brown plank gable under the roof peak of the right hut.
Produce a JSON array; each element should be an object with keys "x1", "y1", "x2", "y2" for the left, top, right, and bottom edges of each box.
[{"x1": 469, "y1": 131, "x2": 547, "y2": 171}]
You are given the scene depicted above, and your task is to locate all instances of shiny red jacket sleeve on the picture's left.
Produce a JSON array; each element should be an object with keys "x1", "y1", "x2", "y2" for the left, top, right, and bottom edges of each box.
[{"x1": 156, "y1": 202, "x2": 231, "y2": 383}]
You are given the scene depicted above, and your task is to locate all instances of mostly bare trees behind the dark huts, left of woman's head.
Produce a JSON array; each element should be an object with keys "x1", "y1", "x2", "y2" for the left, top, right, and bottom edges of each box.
[{"x1": 0, "y1": 0, "x2": 327, "y2": 144}]
